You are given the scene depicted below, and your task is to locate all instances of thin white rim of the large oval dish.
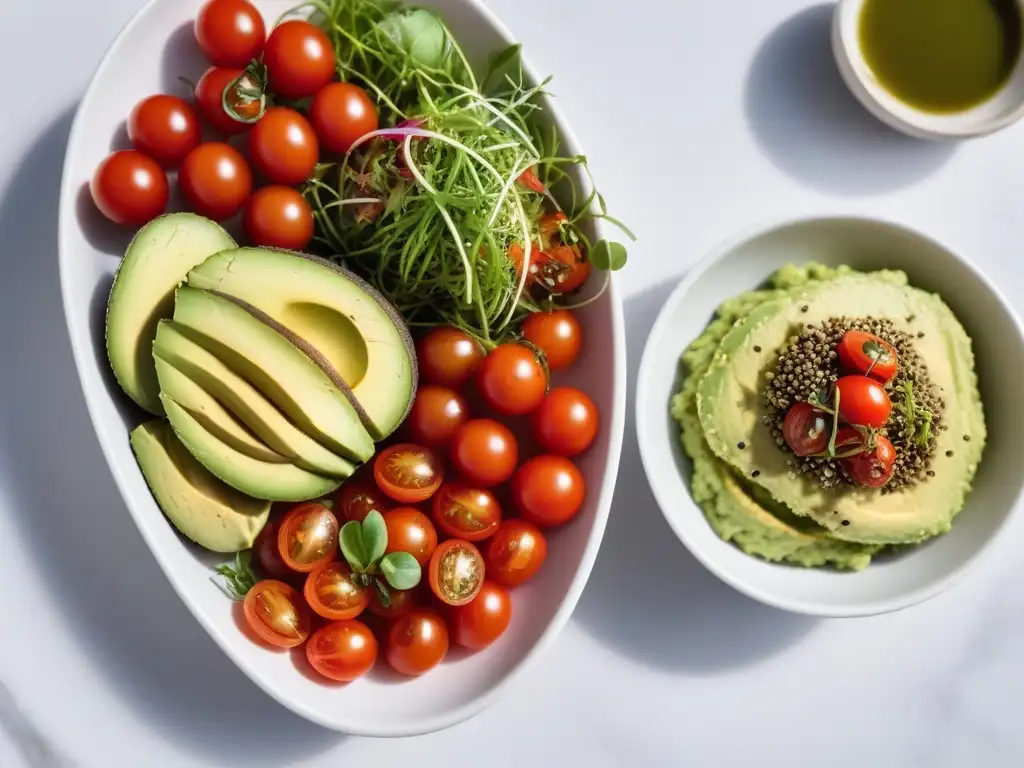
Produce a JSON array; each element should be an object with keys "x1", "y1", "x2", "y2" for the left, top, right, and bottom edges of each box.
[{"x1": 57, "y1": 0, "x2": 627, "y2": 737}]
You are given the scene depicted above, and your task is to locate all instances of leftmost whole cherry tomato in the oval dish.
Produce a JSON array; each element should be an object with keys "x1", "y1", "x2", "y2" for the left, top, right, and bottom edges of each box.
[{"x1": 89, "y1": 150, "x2": 170, "y2": 226}]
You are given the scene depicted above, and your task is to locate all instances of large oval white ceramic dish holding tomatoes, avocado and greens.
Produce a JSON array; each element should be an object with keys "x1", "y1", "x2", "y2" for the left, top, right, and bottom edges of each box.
[{"x1": 59, "y1": 0, "x2": 626, "y2": 736}]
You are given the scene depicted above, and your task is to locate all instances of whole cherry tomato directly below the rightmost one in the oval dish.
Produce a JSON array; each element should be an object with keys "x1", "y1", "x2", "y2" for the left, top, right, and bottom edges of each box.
[{"x1": 512, "y1": 456, "x2": 586, "y2": 526}]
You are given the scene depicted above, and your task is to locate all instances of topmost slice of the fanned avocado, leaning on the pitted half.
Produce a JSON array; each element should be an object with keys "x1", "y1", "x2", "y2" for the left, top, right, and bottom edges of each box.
[{"x1": 174, "y1": 286, "x2": 374, "y2": 462}]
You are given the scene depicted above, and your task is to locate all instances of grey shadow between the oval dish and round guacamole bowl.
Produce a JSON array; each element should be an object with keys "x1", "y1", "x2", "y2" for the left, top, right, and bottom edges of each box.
[{"x1": 573, "y1": 280, "x2": 817, "y2": 675}]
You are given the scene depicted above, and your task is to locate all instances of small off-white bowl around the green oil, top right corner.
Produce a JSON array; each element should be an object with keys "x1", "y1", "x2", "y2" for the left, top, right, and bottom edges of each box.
[{"x1": 831, "y1": 0, "x2": 1024, "y2": 139}]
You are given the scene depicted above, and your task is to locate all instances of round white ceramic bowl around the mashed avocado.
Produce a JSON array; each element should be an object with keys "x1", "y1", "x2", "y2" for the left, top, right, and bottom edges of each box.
[{"x1": 636, "y1": 218, "x2": 1024, "y2": 616}]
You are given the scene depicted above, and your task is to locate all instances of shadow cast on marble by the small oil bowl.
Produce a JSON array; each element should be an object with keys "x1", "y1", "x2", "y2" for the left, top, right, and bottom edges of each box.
[{"x1": 743, "y1": 3, "x2": 956, "y2": 196}]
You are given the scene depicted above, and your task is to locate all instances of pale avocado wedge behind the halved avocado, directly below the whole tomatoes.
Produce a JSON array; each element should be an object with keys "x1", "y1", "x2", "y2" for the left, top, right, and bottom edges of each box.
[{"x1": 106, "y1": 213, "x2": 236, "y2": 416}]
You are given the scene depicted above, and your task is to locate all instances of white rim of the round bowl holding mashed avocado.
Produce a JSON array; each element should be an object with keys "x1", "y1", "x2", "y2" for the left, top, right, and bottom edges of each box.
[{"x1": 635, "y1": 213, "x2": 1024, "y2": 618}]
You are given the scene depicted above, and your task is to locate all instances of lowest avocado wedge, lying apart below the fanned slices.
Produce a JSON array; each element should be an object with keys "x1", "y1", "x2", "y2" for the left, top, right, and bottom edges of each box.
[{"x1": 130, "y1": 421, "x2": 270, "y2": 552}]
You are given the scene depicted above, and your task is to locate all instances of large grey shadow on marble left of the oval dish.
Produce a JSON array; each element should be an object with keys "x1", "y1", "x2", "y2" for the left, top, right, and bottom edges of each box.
[{"x1": 0, "y1": 109, "x2": 345, "y2": 766}]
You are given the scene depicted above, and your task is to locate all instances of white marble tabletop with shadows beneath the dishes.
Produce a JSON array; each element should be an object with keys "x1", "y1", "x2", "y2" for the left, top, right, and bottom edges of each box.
[{"x1": 0, "y1": 0, "x2": 1024, "y2": 768}]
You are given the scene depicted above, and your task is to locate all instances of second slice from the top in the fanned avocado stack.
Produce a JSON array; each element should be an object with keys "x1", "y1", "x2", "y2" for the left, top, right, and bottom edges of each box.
[{"x1": 153, "y1": 321, "x2": 355, "y2": 479}]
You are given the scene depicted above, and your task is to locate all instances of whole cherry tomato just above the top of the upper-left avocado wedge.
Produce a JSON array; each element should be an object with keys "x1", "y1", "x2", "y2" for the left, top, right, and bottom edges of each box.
[{"x1": 178, "y1": 141, "x2": 253, "y2": 221}]
